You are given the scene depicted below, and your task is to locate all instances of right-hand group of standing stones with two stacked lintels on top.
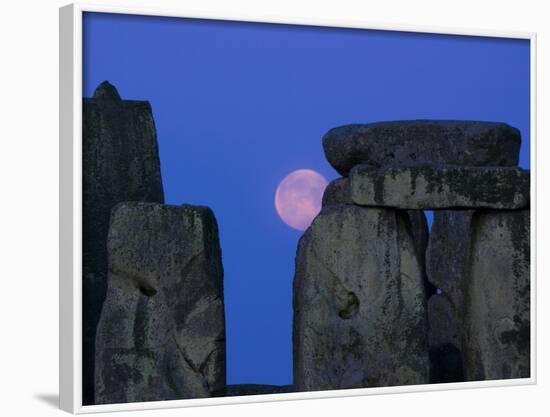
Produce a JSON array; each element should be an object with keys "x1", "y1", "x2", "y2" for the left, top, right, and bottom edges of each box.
[{"x1": 293, "y1": 121, "x2": 529, "y2": 390}]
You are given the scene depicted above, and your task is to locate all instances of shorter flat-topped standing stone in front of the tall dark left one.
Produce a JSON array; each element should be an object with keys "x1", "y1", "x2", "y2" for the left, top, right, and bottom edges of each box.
[{"x1": 95, "y1": 203, "x2": 225, "y2": 404}]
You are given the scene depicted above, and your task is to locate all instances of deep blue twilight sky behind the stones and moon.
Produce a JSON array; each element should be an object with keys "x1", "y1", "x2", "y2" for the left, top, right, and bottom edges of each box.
[{"x1": 83, "y1": 13, "x2": 530, "y2": 384}]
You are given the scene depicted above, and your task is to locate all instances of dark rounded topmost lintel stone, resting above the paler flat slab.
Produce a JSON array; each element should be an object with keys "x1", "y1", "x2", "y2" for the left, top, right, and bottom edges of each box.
[{"x1": 323, "y1": 120, "x2": 521, "y2": 177}]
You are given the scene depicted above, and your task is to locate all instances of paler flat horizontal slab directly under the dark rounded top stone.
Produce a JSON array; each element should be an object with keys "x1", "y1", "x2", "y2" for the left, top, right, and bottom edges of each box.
[{"x1": 350, "y1": 165, "x2": 530, "y2": 210}]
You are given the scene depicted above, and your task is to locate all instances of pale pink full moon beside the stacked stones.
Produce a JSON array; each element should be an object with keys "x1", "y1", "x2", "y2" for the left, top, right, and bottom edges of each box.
[{"x1": 275, "y1": 169, "x2": 327, "y2": 231}]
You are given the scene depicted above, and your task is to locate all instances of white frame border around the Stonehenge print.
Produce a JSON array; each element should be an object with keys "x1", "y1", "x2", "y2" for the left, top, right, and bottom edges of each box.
[{"x1": 59, "y1": 3, "x2": 538, "y2": 414}]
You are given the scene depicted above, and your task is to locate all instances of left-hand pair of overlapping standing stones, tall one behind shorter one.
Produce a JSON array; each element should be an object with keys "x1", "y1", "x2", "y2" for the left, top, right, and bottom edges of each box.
[{"x1": 83, "y1": 82, "x2": 225, "y2": 405}]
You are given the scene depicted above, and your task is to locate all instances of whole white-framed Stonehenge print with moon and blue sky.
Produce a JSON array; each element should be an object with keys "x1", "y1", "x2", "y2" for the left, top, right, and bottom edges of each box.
[{"x1": 60, "y1": 4, "x2": 536, "y2": 413}]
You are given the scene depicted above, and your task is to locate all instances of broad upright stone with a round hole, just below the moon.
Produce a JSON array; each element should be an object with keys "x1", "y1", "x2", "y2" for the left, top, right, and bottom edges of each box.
[{"x1": 293, "y1": 205, "x2": 429, "y2": 391}]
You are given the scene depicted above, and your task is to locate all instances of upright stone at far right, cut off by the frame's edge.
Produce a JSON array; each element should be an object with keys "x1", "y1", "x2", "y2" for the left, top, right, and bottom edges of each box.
[{"x1": 463, "y1": 210, "x2": 530, "y2": 381}]
